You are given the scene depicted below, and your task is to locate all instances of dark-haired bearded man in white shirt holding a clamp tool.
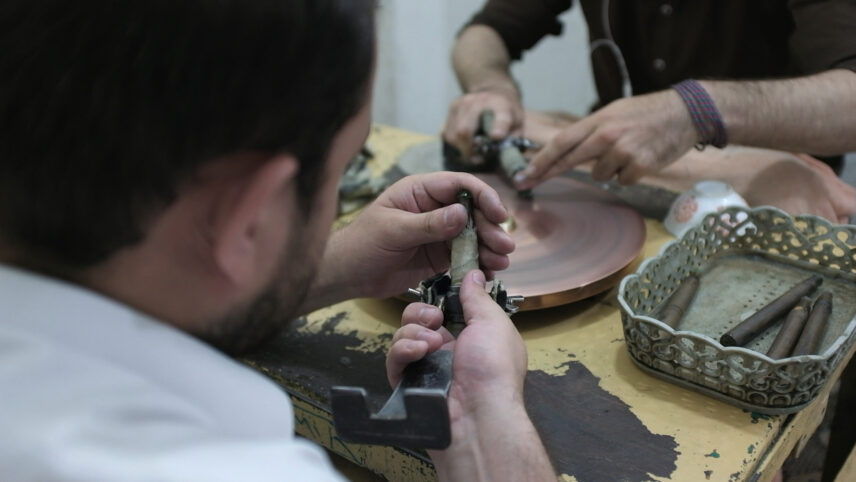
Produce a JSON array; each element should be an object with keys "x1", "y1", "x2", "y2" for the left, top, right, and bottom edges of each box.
[{"x1": 0, "y1": 0, "x2": 554, "y2": 481}]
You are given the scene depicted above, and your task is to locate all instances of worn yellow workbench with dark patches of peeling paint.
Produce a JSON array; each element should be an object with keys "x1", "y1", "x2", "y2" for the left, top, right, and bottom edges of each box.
[{"x1": 242, "y1": 127, "x2": 856, "y2": 482}]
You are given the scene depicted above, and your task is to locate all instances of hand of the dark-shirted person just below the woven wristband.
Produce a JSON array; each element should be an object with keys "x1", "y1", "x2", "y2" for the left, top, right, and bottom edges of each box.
[{"x1": 515, "y1": 90, "x2": 698, "y2": 189}]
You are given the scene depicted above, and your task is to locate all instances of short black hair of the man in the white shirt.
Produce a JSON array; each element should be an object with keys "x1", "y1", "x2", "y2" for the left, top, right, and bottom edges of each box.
[{"x1": 0, "y1": 0, "x2": 374, "y2": 272}]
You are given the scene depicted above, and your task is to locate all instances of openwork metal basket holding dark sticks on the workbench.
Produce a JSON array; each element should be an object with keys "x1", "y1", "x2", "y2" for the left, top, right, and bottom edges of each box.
[{"x1": 618, "y1": 207, "x2": 856, "y2": 414}]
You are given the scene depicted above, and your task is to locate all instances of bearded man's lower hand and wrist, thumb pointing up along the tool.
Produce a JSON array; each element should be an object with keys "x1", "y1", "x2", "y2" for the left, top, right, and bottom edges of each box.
[{"x1": 387, "y1": 270, "x2": 556, "y2": 480}]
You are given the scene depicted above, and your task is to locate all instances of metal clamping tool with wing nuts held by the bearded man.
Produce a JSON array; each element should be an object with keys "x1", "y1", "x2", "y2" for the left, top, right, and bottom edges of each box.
[{"x1": 330, "y1": 191, "x2": 523, "y2": 449}]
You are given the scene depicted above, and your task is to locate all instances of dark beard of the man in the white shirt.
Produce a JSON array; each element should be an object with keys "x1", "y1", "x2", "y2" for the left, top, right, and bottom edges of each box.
[{"x1": 196, "y1": 228, "x2": 325, "y2": 355}]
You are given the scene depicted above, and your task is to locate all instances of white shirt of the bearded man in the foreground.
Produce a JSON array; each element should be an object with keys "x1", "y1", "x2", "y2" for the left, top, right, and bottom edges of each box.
[{"x1": 0, "y1": 265, "x2": 341, "y2": 481}]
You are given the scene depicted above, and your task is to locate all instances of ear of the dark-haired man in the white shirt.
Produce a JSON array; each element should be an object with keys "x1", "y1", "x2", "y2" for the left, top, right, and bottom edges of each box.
[{"x1": 211, "y1": 154, "x2": 299, "y2": 285}]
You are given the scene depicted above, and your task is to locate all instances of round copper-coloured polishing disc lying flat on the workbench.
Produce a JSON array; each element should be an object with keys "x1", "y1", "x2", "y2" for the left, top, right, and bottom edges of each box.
[{"x1": 478, "y1": 174, "x2": 645, "y2": 311}]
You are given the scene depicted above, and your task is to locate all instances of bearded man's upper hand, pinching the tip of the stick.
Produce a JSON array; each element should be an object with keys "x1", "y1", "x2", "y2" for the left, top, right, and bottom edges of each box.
[{"x1": 301, "y1": 172, "x2": 514, "y2": 313}]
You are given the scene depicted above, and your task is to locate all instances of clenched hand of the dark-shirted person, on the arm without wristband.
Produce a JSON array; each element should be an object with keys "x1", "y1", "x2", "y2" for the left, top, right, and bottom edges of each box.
[{"x1": 443, "y1": 88, "x2": 523, "y2": 159}]
